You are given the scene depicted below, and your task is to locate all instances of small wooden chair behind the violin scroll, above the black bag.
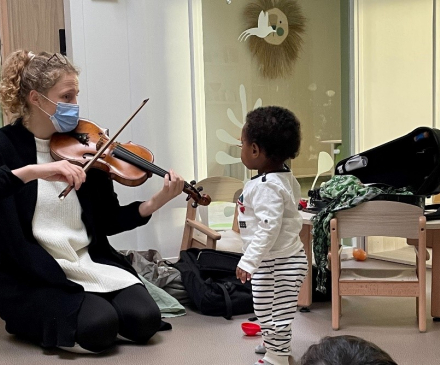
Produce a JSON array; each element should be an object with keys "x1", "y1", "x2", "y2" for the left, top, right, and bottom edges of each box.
[{"x1": 180, "y1": 176, "x2": 244, "y2": 252}]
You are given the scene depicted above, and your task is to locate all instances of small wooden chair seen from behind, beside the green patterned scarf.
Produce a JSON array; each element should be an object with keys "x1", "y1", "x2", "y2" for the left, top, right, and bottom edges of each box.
[{"x1": 330, "y1": 201, "x2": 426, "y2": 332}]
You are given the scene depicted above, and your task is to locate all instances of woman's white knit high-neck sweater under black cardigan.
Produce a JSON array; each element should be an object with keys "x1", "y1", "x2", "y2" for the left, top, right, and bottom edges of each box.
[{"x1": 32, "y1": 138, "x2": 141, "y2": 293}]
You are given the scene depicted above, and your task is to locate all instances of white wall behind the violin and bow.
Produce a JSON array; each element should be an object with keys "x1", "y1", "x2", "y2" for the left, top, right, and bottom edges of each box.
[{"x1": 65, "y1": 0, "x2": 195, "y2": 257}]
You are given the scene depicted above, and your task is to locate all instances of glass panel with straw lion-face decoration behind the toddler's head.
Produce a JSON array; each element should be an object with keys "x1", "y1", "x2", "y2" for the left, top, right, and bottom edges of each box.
[{"x1": 190, "y1": 0, "x2": 341, "y2": 197}]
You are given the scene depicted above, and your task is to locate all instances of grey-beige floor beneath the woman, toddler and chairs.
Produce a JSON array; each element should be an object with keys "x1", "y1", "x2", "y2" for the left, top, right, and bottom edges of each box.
[{"x1": 0, "y1": 260, "x2": 440, "y2": 365}]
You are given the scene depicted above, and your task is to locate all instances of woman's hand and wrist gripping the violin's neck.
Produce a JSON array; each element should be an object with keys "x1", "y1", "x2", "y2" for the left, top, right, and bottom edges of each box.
[{"x1": 139, "y1": 170, "x2": 185, "y2": 217}]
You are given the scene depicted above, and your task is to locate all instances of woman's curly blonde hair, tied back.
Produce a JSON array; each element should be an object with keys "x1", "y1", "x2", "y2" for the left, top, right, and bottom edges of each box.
[{"x1": 0, "y1": 50, "x2": 79, "y2": 121}]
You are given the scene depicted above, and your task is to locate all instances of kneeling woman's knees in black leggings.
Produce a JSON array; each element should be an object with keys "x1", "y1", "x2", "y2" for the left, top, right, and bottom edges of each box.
[{"x1": 76, "y1": 284, "x2": 161, "y2": 352}]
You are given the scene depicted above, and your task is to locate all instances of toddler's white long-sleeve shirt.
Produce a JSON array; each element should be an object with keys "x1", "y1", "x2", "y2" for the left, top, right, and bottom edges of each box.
[{"x1": 238, "y1": 170, "x2": 303, "y2": 274}]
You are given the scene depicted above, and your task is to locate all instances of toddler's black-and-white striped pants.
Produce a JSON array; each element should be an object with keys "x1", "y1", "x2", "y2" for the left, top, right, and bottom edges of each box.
[{"x1": 252, "y1": 250, "x2": 308, "y2": 356}]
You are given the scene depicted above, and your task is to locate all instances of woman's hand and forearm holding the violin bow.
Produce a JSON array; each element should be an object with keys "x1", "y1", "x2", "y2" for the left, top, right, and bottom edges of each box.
[{"x1": 12, "y1": 160, "x2": 86, "y2": 190}]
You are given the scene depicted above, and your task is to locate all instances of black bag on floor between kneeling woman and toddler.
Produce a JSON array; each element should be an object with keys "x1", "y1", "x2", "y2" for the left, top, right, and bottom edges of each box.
[{"x1": 174, "y1": 248, "x2": 254, "y2": 319}]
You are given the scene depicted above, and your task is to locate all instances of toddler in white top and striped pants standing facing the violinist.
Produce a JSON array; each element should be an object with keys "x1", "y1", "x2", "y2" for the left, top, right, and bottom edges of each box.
[{"x1": 236, "y1": 106, "x2": 308, "y2": 365}]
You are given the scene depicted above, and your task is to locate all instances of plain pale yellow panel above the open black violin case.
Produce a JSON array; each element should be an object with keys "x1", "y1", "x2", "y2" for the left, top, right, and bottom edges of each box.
[{"x1": 355, "y1": 0, "x2": 434, "y2": 152}]
